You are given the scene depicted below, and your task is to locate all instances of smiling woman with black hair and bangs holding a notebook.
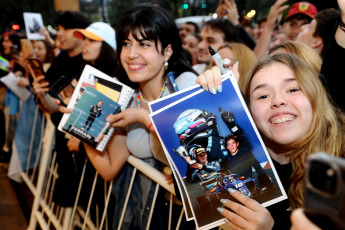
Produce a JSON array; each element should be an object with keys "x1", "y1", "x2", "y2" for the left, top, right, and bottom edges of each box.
[{"x1": 81, "y1": 4, "x2": 197, "y2": 229}]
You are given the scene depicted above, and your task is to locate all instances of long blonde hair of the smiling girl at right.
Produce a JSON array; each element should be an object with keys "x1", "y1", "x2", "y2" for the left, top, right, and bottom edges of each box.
[{"x1": 244, "y1": 53, "x2": 345, "y2": 209}]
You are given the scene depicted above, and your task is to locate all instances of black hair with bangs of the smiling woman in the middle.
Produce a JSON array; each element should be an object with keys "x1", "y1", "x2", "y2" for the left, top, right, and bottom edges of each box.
[{"x1": 116, "y1": 4, "x2": 196, "y2": 88}]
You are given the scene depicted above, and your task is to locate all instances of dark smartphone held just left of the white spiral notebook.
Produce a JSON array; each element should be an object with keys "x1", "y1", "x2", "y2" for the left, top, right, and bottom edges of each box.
[{"x1": 50, "y1": 76, "x2": 74, "y2": 106}]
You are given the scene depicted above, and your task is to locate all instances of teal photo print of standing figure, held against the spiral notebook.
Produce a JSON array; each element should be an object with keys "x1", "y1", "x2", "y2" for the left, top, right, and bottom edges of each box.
[{"x1": 63, "y1": 86, "x2": 121, "y2": 151}]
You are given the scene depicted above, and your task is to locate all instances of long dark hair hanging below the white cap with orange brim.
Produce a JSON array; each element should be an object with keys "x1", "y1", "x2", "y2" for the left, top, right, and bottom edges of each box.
[{"x1": 86, "y1": 41, "x2": 117, "y2": 77}]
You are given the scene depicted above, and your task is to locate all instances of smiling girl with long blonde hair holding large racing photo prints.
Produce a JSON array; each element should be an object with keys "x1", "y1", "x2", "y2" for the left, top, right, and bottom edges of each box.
[{"x1": 197, "y1": 53, "x2": 345, "y2": 229}]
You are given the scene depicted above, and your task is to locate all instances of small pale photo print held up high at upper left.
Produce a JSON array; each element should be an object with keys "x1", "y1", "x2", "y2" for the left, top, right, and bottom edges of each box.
[{"x1": 23, "y1": 12, "x2": 45, "y2": 40}]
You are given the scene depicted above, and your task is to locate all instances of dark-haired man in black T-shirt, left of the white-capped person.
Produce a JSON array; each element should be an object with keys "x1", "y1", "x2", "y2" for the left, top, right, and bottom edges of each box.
[{"x1": 33, "y1": 11, "x2": 90, "y2": 114}]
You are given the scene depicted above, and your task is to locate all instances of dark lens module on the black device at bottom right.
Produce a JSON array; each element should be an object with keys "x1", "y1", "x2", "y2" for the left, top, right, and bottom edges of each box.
[{"x1": 309, "y1": 161, "x2": 337, "y2": 194}]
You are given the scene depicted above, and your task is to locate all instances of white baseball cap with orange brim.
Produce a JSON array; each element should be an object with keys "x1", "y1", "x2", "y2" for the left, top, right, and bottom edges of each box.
[{"x1": 73, "y1": 22, "x2": 116, "y2": 50}]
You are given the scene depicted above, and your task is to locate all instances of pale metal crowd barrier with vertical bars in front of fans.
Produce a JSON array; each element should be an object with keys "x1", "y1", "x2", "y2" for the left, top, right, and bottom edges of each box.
[{"x1": 21, "y1": 114, "x2": 187, "y2": 230}]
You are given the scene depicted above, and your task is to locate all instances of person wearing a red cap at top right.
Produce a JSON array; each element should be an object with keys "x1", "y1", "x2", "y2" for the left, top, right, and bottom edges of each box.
[{"x1": 285, "y1": 2, "x2": 317, "y2": 41}]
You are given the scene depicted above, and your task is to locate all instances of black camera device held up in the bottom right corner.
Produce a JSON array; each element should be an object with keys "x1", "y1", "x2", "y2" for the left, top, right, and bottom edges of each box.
[{"x1": 304, "y1": 152, "x2": 345, "y2": 229}]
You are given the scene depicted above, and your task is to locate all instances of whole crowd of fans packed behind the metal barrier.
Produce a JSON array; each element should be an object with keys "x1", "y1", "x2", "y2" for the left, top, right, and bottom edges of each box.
[{"x1": 0, "y1": 0, "x2": 345, "y2": 229}]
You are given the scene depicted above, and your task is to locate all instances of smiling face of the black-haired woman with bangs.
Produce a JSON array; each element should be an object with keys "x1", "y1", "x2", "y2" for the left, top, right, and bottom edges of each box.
[{"x1": 120, "y1": 33, "x2": 170, "y2": 83}]
